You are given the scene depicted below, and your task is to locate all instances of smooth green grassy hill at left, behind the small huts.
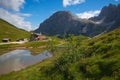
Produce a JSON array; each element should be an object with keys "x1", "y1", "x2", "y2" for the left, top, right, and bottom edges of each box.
[{"x1": 0, "y1": 19, "x2": 30, "y2": 42}]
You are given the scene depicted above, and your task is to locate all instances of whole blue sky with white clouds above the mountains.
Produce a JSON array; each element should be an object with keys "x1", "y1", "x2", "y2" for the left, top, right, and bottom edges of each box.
[{"x1": 0, "y1": 0, "x2": 120, "y2": 30}]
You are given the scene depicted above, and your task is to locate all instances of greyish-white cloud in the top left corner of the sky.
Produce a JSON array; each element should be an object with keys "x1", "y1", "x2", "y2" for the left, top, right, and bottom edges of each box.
[{"x1": 0, "y1": 0, "x2": 25, "y2": 11}]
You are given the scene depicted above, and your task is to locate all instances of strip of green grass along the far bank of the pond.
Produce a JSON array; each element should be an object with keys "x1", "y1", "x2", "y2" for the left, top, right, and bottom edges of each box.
[{"x1": 0, "y1": 38, "x2": 63, "y2": 55}]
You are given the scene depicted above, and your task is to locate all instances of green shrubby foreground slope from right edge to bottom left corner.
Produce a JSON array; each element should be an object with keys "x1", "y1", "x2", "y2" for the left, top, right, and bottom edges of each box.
[{"x1": 0, "y1": 28, "x2": 120, "y2": 80}]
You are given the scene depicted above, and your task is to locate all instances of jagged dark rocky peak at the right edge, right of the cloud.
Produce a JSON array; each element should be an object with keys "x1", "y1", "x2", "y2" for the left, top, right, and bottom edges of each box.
[{"x1": 90, "y1": 4, "x2": 120, "y2": 31}]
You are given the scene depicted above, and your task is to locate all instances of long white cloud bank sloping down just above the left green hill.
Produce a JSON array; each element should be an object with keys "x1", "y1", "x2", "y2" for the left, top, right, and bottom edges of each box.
[{"x1": 0, "y1": 8, "x2": 32, "y2": 31}]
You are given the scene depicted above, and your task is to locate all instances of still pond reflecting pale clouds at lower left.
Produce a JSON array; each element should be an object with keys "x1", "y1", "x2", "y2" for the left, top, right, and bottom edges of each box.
[{"x1": 0, "y1": 50, "x2": 52, "y2": 74}]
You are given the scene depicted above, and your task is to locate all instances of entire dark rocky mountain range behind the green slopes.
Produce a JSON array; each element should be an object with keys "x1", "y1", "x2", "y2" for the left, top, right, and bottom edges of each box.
[{"x1": 34, "y1": 4, "x2": 120, "y2": 37}]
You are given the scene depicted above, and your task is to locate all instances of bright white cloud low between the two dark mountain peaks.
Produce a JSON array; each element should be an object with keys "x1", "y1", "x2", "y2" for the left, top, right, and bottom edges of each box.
[{"x1": 76, "y1": 10, "x2": 100, "y2": 19}]
